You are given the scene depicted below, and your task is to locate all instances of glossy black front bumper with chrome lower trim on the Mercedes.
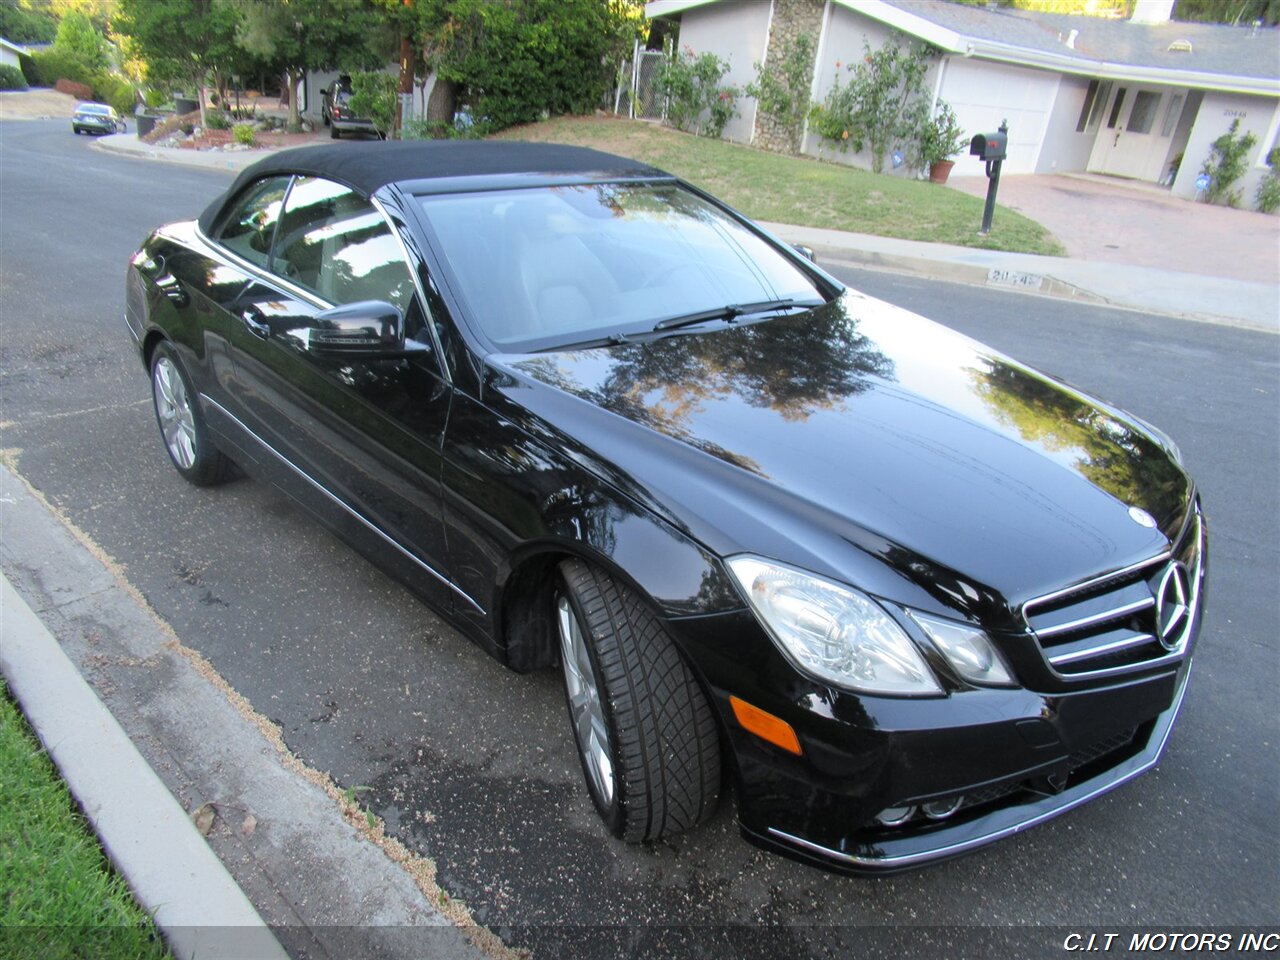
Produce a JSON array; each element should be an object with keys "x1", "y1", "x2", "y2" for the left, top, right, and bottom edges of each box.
[{"x1": 673, "y1": 570, "x2": 1203, "y2": 874}]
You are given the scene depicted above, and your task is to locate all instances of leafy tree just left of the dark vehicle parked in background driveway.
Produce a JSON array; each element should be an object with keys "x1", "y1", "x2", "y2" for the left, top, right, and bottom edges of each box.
[{"x1": 236, "y1": 0, "x2": 394, "y2": 129}]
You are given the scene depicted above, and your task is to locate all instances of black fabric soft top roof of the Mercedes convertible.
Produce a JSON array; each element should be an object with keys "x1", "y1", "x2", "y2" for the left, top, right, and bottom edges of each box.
[{"x1": 200, "y1": 140, "x2": 669, "y2": 233}]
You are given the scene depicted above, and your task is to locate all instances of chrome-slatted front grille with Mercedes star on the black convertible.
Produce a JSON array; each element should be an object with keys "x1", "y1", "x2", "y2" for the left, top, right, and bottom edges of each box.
[{"x1": 1023, "y1": 508, "x2": 1203, "y2": 680}]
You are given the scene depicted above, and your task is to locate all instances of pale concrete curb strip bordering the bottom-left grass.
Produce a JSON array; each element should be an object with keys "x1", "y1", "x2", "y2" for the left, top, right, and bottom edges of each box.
[{"x1": 0, "y1": 573, "x2": 288, "y2": 960}]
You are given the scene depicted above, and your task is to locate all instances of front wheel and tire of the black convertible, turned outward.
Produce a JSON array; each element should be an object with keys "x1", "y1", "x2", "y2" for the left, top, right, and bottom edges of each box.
[{"x1": 553, "y1": 559, "x2": 721, "y2": 844}]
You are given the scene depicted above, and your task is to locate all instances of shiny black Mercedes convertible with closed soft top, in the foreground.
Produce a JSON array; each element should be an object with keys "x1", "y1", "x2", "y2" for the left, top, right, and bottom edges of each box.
[{"x1": 125, "y1": 142, "x2": 1206, "y2": 872}]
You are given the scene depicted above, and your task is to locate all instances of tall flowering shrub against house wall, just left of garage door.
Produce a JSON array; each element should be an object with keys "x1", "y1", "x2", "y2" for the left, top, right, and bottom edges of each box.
[{"x1": 809, "y1": 41, "x2": 934, "y2": 173}]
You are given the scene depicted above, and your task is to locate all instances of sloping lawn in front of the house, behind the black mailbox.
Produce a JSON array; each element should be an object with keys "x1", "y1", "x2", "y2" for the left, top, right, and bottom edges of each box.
[{"x1": 497, "y1": 116, "x2": 1065, "y2": 256}]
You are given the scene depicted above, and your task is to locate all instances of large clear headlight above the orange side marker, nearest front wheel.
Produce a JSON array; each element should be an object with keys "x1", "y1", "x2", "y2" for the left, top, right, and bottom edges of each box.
[{"x1": 727, "y1": 557, "x2": 942, "y2": 696}]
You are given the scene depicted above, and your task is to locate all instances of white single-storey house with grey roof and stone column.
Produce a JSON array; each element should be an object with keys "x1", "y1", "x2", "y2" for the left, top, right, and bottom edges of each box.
[{"x1": 645, "y1": 0, "x2": 1280, "y2": 197}]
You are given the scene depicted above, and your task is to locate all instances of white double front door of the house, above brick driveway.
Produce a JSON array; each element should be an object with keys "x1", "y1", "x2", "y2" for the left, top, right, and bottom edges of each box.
[{"x1": 1088, "y1": 83, "x2": 1187, "y2": 180}]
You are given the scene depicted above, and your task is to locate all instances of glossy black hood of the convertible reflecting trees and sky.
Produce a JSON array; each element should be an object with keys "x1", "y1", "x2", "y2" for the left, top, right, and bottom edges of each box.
[{"x1": 489, "y1": 292, "x2": 1192, "y2": 624}]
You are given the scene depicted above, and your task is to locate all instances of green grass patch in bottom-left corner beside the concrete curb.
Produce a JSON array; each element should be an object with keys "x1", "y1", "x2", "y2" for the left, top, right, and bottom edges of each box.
[{"x1": 0, "y1": 680, "x2": 169, "y2": 960}]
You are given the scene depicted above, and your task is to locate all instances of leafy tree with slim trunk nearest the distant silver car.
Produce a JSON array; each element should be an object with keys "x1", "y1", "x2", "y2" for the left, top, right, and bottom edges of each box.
[{"x1": 115, "y1": 0, "x2": 239, "y2": 125}]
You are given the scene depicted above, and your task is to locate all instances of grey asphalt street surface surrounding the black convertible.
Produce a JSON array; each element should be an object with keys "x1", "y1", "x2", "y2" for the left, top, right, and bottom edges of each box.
[{"x1": 0, "y1": 122, "x2": 1280, "y2": 956}]
